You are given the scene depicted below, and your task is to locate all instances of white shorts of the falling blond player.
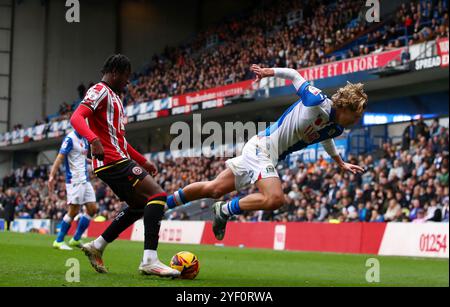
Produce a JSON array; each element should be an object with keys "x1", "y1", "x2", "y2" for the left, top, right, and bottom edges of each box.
[{"x1": 226, "y1": 136, "x2": 279, "y2": 191}]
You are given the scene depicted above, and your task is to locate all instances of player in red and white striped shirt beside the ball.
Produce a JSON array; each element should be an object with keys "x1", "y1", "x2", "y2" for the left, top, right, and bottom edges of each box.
[{"x1": 71, "y1": 54, "x2": 180, "y2": 277}]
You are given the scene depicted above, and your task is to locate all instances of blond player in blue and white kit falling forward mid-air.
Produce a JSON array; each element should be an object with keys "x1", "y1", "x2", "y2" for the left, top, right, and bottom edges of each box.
[{"x1": 167, "y1": 65, "x2": 368, "y2": 240}]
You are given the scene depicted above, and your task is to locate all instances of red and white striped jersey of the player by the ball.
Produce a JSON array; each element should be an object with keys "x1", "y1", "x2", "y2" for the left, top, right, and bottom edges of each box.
[{"x1": 81, "y1": 82, "x2": 130, "y2": 170}]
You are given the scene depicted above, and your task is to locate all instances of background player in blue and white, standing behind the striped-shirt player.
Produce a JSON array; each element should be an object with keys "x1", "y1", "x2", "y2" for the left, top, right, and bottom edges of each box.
[{"x1": 48, "y1": 131, "x2": 98, "y2": 250}]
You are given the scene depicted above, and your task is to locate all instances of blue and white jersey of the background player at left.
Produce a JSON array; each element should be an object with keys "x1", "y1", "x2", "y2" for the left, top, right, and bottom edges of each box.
[{"x1": 59, "y1": 131, "x2": 89, "y2": 184}]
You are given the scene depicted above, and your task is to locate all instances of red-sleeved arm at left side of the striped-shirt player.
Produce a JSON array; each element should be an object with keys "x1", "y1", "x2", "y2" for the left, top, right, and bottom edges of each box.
[{"x1": 70, "y1": 105, "x2": 105, "y2": 161}]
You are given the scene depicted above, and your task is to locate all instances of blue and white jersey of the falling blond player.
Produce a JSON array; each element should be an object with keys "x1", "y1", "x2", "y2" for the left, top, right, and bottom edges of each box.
[{"x1": 259, "y1": 79, "x2": 344, "y2": 162}]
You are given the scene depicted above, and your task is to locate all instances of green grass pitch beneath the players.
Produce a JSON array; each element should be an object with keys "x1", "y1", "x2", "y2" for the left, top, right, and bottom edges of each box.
[{"x1": 0, "y1": 233, "x2": 449, "y2": 287}]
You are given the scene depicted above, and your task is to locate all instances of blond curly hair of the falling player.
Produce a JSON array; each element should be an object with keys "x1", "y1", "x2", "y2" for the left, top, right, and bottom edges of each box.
[{"x1": 331, "y1": 82, "x2": 369, "y2": 114}]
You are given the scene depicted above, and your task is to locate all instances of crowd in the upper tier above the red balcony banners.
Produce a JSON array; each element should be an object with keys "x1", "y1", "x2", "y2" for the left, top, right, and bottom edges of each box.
[{"x1": 6, "y1": 0, "x2": 449, "y2": 130}]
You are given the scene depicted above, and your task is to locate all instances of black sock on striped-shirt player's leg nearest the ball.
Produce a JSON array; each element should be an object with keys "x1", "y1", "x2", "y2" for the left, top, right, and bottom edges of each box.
[{"x1": 144, "y1": 193, "x2": 167, "y2": 251}]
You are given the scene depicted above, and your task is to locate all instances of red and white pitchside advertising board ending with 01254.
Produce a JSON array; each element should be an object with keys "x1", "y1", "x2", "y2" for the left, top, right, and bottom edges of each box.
[{"x1": 66, "y1": 220, "x2": 450, "y2": 259}]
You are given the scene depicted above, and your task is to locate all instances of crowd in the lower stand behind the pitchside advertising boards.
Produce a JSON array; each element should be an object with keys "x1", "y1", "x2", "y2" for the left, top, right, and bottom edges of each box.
[{"x1": 0, "y1": 121, "x2": 449, "y2": 223}]
